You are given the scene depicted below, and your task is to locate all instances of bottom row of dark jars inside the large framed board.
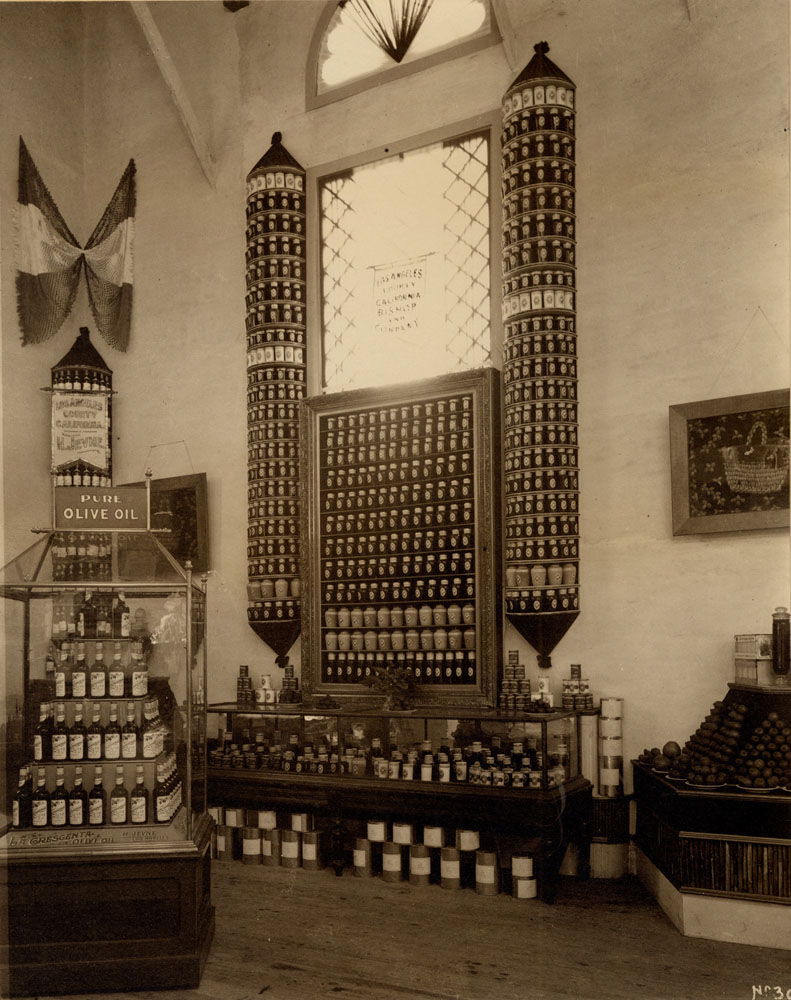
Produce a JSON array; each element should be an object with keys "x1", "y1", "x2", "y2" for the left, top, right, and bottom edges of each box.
[{"x1": 322, "y1": 649, "x2": 478, "y2": 684}]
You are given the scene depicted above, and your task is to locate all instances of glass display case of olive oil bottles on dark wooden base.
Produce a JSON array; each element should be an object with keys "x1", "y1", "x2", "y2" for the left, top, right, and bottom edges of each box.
[{"x1": 0, "y1": 530, "x2": 214, "y2": 995}]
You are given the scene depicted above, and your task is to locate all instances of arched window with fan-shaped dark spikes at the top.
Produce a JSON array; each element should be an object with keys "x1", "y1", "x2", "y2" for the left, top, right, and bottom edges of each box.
[{"x1": 306, "y1": 0, "x2": 500, "y2": 109}]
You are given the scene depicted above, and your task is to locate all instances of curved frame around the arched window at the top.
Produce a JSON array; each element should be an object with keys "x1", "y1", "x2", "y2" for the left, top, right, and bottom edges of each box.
[{"x1": 305, "y1": 0, "x2": 503, "y2": 111}]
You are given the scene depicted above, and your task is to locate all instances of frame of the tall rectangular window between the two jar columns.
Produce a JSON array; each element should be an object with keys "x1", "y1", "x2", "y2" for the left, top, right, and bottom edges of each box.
[{"x1": 305, "y1": 113, "x2": 503, "y2": 396}]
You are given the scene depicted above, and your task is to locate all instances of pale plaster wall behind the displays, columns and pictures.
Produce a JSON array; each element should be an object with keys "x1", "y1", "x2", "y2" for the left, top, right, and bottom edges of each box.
[{"x1": 0, "y1": 0, "x2": 789, "y2": 772}]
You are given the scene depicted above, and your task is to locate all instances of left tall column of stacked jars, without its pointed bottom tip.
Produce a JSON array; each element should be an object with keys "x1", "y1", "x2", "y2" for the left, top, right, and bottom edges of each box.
[{"x1": 246, "y1": 132, "x2": 306, "y2": 628}]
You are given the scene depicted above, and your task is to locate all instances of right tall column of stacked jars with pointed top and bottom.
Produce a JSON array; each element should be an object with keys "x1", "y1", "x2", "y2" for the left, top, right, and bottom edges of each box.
[{"x1": 501, "y1": 42, "x2": 579, "y2": 667}]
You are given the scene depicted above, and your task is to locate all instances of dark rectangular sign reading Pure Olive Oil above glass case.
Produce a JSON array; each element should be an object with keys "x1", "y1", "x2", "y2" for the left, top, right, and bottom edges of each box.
[{"x1": 55, "y1": 486, "x2": 148, "y2": 531}]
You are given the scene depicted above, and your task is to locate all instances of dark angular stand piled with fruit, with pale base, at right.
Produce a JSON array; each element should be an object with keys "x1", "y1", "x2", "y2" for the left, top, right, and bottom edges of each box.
[{"x1": 632, "y1": 684, "x2": 791, "y2": 949}]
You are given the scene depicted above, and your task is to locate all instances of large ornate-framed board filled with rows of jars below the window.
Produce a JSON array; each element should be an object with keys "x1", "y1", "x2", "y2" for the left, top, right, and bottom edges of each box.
[{"x1": 300, "y1": 368, "x2": 502, "y2": 705}]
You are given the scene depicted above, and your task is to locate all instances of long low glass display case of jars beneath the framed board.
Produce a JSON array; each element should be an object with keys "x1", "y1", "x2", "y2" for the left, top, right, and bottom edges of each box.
[{"x1": 209, "y1": 704, "x2": 580, "y2": 794}]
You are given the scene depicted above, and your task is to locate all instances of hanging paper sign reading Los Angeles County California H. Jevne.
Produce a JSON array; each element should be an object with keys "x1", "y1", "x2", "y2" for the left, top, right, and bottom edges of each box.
[{"x1": 52, "y1": 392, "x2": 110, "y2": 469}]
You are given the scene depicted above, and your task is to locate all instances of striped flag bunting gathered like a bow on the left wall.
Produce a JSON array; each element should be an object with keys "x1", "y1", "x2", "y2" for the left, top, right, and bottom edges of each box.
[{"x1": 16, "y1": 136, "x2": 135, "y2": 351}]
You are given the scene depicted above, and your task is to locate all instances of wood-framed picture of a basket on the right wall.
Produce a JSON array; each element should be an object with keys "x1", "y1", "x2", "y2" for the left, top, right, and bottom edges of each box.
[{"x1": 670, "y1": 389, "x2": 789, "y2": 535}]
